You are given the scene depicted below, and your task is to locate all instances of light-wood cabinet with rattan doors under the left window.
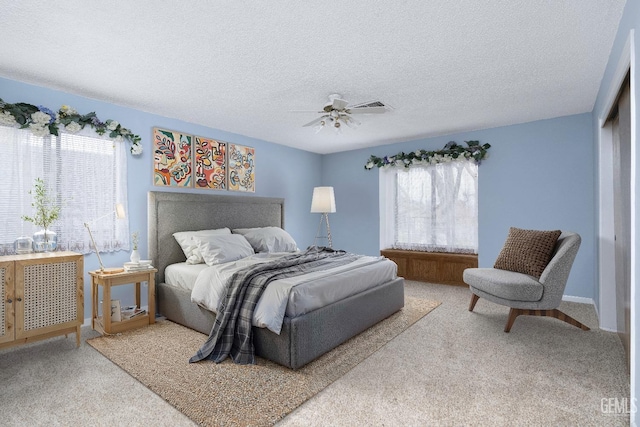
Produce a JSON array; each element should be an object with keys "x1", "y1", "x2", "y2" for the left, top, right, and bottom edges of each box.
[{"x1": 0, "y1": 252, "x2": 84, "y2": 348}]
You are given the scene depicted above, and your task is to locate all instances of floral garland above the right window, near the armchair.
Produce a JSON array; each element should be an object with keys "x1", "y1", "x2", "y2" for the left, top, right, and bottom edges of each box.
[{"x1": 364, "y1": 141, "x2": 491, "y2": 170}]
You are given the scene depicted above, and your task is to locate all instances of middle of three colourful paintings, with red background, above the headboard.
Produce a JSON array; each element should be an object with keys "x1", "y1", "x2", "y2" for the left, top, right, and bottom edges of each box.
[{"x1": 193, "y1": 136, "x2": 227, "y2": 190}]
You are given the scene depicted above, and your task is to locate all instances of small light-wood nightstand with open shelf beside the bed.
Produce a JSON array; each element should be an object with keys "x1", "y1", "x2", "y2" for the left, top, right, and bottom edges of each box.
[{"x1": 89, "y1": 268, "x2": 158, "y2": 334}]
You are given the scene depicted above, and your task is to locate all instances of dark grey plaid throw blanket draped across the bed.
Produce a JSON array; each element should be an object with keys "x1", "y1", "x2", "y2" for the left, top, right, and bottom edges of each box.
[{"x1": 189, "y1": 247, "x2": 358, "y2": 365}]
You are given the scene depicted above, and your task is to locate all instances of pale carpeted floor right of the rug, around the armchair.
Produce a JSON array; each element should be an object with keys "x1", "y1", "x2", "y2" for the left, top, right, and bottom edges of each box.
[{"x1": 278, "y1": 281, "x2": 629, "y2": 427}]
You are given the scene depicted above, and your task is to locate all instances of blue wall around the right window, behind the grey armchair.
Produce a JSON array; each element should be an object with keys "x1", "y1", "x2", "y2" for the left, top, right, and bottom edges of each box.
[{"x1": 322, "y1": 114, "x2": 595, "y2": 298}]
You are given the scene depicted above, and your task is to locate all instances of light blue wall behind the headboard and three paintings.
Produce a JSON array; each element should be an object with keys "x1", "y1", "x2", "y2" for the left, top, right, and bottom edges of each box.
[{"x1": 0, "y1": 78, "x2": 321, "y2": 318}]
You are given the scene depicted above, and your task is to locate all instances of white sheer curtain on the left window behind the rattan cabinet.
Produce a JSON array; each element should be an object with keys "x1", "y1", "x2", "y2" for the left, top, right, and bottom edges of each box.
[{"x1": 0, "y1": 126, "x2": 129, "y2": 254}]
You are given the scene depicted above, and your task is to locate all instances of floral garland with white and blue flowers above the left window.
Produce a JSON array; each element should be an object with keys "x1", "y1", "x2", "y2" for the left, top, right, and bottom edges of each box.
[{"x1": 0, "y1": 98, "x2": 142, "y2": 156}]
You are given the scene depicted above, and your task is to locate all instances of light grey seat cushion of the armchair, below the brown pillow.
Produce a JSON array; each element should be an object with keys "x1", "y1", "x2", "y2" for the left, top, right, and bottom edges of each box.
[{"x1": 462, "y1": 268, "x2": 544, "y2": 301}]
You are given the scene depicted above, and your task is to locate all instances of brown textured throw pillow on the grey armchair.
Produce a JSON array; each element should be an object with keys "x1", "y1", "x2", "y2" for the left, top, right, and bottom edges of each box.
[{"x1": 493, "y1": 227, "x2": 562, "y2": 279}]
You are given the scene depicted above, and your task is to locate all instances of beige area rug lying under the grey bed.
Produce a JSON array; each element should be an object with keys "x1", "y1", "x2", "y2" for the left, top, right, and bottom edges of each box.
[{"x1": 87, "y1": 297, "x2": 440, "y2": 426}]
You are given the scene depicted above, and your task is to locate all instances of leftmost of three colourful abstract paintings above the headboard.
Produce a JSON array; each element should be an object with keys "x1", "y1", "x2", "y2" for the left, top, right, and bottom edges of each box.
[{"x1": 153, "y1": 128, "x2": 193, "y2": 187}]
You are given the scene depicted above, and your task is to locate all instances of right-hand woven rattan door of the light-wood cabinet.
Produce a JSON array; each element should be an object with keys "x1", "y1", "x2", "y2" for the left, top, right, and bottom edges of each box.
[{"x1": 15, "y1": 256, "x2": 82, "y2": 339}]
